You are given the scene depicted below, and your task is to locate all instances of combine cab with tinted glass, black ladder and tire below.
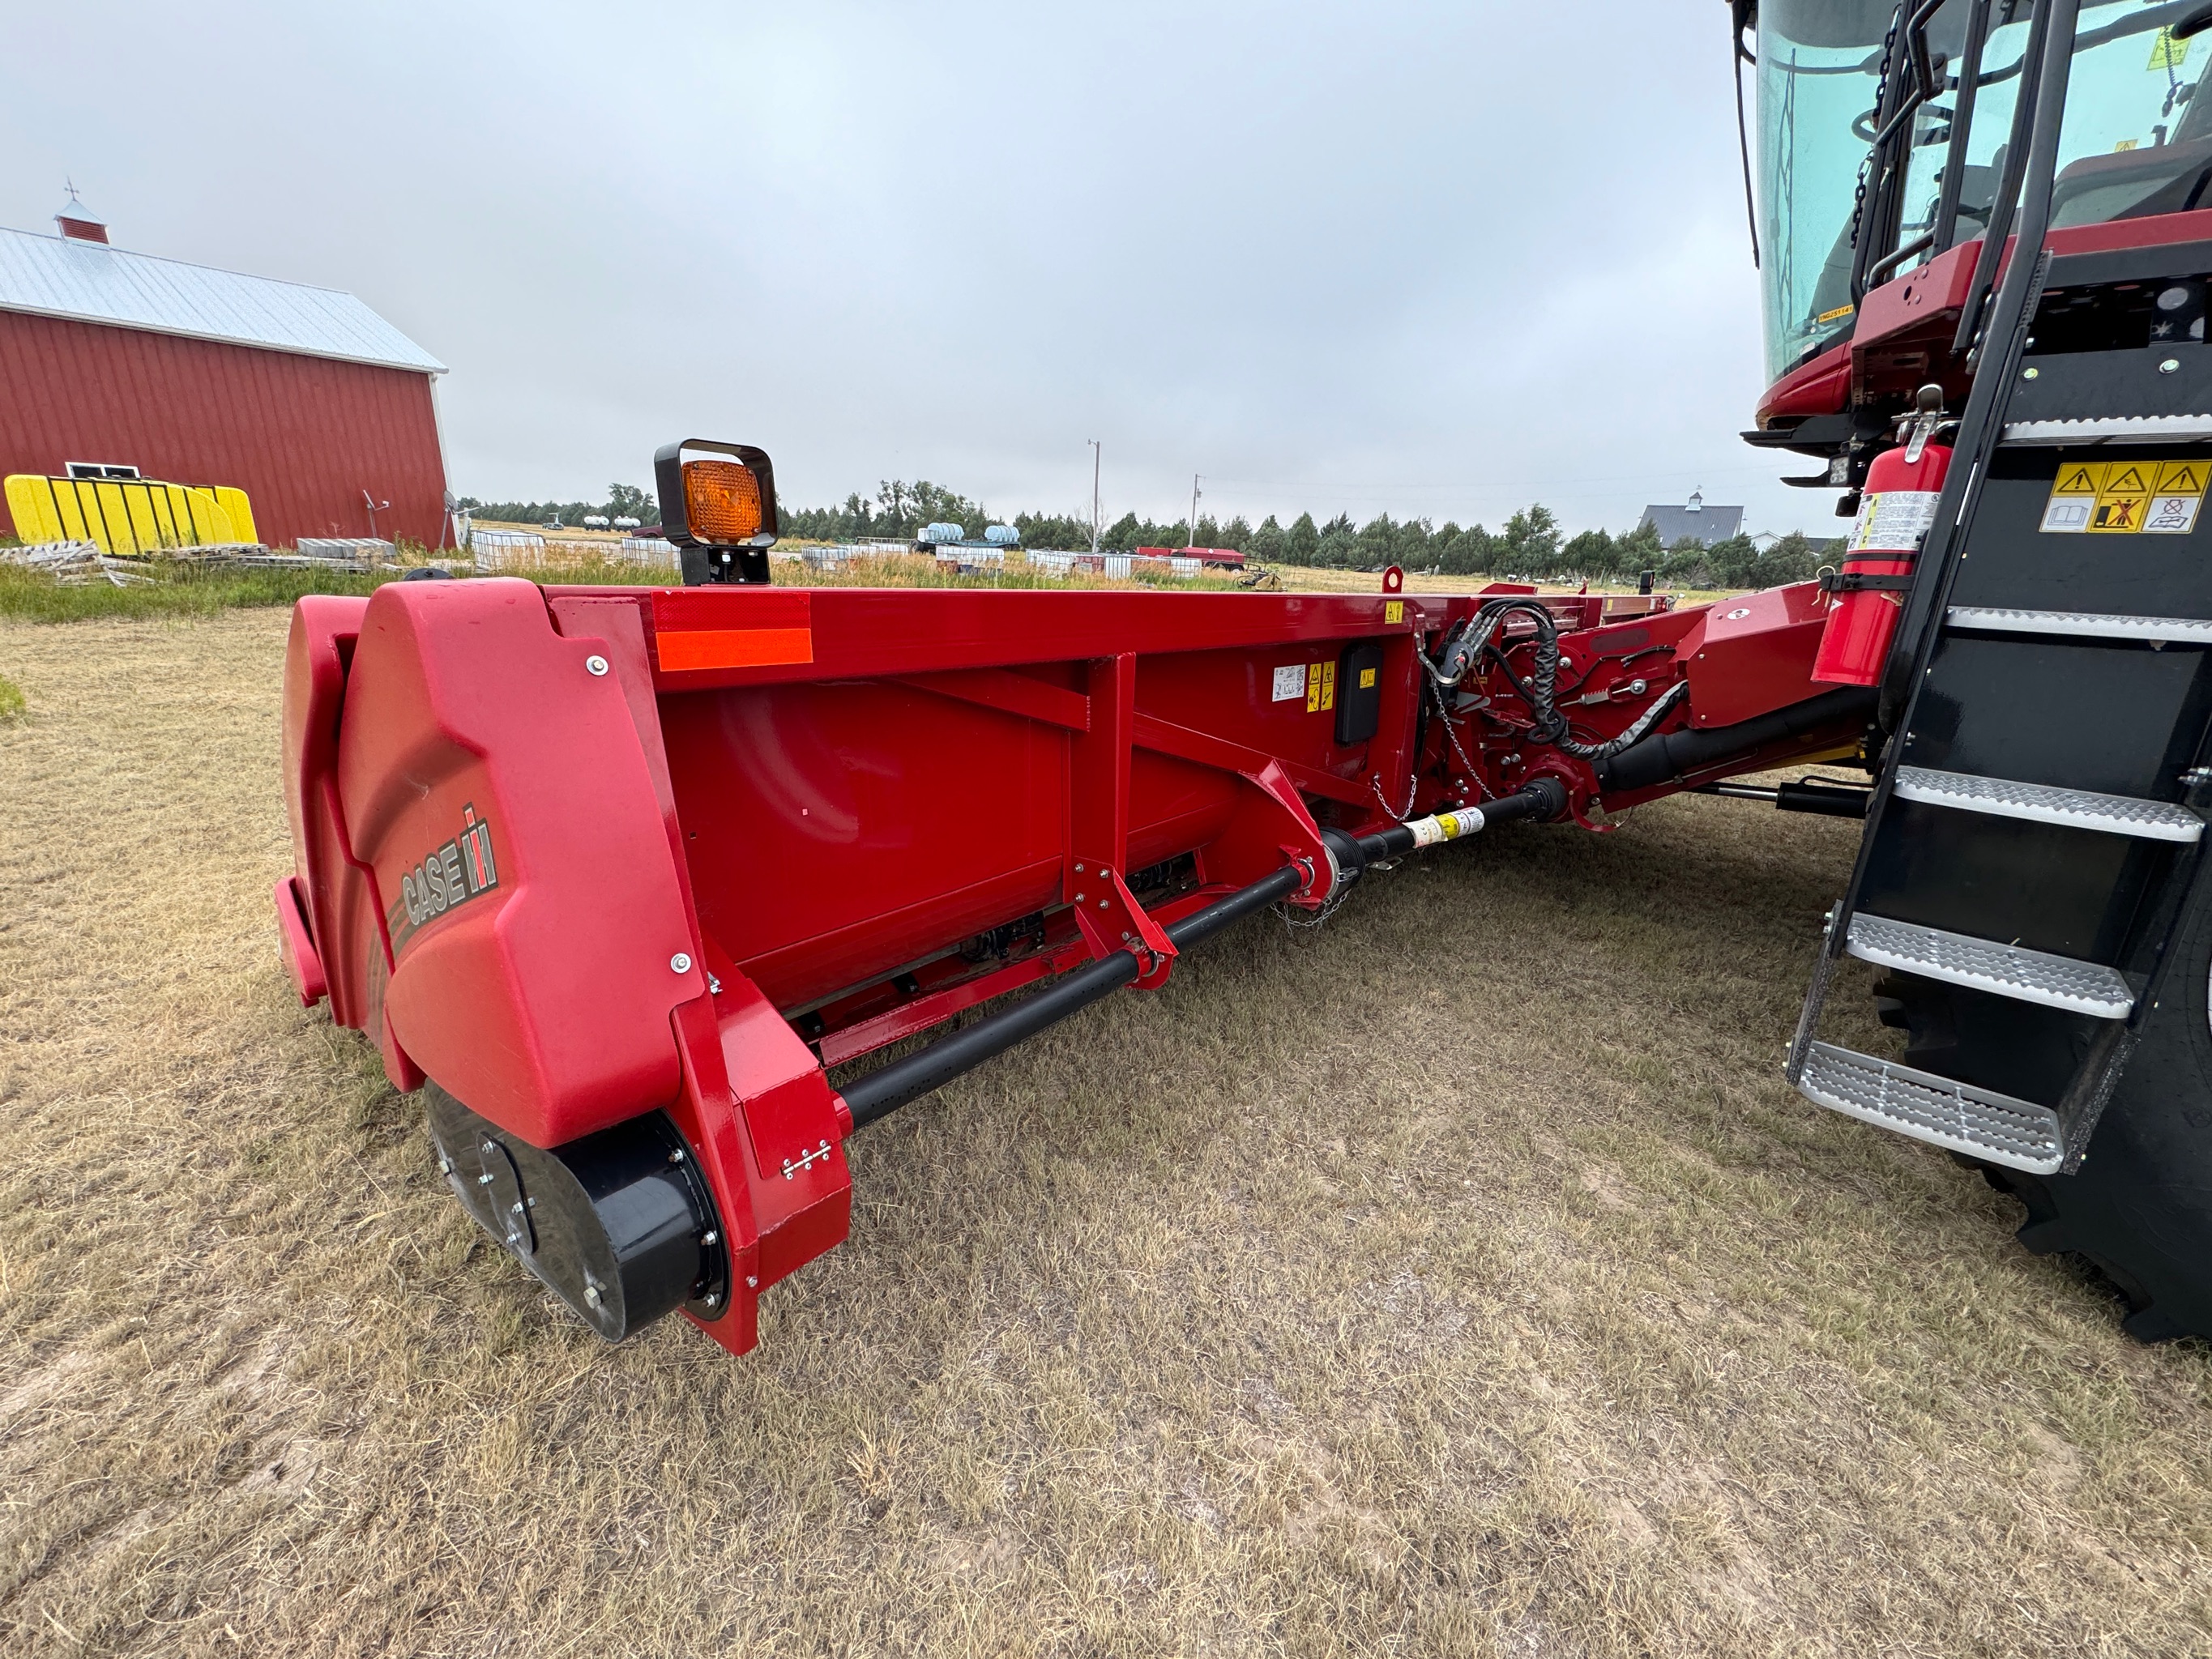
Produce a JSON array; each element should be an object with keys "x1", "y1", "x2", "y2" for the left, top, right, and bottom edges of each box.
[{"x1": 1734, "y1": 0, "x2": 2212, "y2": 1338}]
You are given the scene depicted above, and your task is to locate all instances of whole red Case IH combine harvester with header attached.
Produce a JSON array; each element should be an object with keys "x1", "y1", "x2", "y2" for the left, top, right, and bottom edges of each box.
[{"x1": 276, "y1": 0, "x2": 2212, "y2": 1354}]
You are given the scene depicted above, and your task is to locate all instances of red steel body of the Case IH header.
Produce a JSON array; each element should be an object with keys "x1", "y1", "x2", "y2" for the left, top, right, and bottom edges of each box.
[{"x1": 279, "y1": 579, "x2": 1854, "y2": 1354}]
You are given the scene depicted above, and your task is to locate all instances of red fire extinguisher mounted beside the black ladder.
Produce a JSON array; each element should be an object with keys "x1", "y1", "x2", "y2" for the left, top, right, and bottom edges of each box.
[{"x1": 1812, "y1": 385, "x2": 1951, "y2": 686}]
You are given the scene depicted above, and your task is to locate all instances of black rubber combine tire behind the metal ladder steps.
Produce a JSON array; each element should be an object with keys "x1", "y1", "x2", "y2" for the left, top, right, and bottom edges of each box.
[{"x1": 1876, "y1": 891, "x2": 2212, "y2": 1343}]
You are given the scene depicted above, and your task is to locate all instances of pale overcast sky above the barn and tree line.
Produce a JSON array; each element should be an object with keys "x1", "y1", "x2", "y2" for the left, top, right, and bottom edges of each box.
[{"x1": 0, "y1": 0, "x2": 1836, "y2": 533}]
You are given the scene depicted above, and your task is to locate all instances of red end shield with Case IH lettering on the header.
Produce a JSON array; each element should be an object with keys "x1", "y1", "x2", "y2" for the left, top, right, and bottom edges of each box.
[{"x1": 336, "y1": 579, "x2": 708, "y2": 1145}]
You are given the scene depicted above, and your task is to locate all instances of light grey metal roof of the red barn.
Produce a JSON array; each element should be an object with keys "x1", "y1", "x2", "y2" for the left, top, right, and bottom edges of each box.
[{"x1": 0, "y1": 228, "x2": 445, "y2": 373}]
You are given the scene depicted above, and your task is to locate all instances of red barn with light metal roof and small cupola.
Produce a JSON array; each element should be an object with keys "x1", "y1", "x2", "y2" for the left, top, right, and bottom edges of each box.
[{"x1": 0, "y1": 203, "x2": 445, "y2": 546}]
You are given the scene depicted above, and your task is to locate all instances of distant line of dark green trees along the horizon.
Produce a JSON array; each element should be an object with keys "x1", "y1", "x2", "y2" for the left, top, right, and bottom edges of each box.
[{"x1": 460, "y1": 478, "x2": 1840, "y2": 588}]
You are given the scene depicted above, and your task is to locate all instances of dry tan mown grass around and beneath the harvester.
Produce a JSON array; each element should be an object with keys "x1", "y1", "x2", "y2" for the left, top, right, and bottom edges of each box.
[{"x1": 0, "y1": 611, "x2": 2212, "y2": 1659}]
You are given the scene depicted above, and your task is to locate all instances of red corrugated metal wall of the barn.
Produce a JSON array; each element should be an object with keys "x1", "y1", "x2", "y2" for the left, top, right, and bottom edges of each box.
[{"x1": 0, "y1": 312, "x2": 445, "y2": 546}]
